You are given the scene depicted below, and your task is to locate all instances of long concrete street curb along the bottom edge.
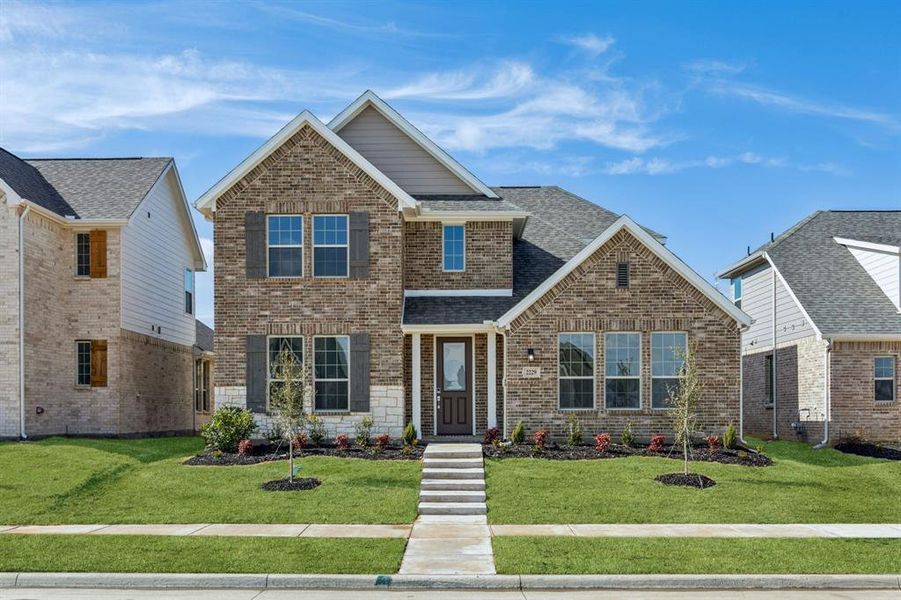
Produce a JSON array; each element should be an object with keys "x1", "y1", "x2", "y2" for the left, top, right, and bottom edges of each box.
[{"x1": 0, "y1": 573, "x2": 901, "y2": 590}]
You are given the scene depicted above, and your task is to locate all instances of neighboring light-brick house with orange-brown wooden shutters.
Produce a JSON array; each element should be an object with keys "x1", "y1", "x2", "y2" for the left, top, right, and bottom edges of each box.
[{"x1": 0, "y1": 149, "x2": 205, "y2": 437}]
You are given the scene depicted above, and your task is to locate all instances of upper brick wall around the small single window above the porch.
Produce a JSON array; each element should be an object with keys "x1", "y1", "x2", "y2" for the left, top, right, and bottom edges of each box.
[{"x1": 404, "y1": 221, "x2": 513, "y2": 290}]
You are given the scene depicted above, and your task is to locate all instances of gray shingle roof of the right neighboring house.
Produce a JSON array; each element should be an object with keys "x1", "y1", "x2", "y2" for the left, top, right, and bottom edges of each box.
[{"x1": 761, "y1": 211, "x2": 901, "y2": 336}]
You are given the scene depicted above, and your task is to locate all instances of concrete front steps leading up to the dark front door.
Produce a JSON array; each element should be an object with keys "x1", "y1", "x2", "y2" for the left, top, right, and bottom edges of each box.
[{"x1": 419, "y1": 444, "x2": 488, "y2": 515}]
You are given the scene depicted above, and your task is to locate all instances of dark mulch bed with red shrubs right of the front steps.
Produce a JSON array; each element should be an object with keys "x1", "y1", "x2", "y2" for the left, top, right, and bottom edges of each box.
[{"x1": 482, "y1": 443, "x2": 773, "y2": 467}]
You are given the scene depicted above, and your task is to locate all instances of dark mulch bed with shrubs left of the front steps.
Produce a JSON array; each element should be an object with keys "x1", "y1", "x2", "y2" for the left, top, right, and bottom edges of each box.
[{"x1": 183, "y1": 445, "x2": 425, "y2": 467}]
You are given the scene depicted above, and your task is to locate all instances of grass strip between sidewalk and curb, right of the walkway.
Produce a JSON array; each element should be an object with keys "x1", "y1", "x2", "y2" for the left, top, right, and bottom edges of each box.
[{"x1": 493, "y1": 537, "x2": 901, "y2": 575}]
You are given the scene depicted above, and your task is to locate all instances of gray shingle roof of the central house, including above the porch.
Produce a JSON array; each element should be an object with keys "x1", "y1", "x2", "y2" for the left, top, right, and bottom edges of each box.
[{"x1": 404, "y1": 186, "x2": 662, "y2": 325}]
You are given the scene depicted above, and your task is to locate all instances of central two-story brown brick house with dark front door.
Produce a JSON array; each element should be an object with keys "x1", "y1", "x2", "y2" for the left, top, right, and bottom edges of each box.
[{"x1": 196, "y1": 92, "x2": 750, "y2": 437}]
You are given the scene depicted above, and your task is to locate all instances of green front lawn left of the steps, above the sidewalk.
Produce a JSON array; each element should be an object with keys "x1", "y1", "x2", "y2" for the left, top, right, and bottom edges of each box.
[{"x1": 0, "y1": 437, "x2": 420, "y2": 524}]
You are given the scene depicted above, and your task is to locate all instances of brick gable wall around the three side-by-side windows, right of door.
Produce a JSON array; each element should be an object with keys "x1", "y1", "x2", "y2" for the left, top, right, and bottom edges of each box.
[{"x1": 506, "y1": 231, "x2": 739, "y2": 439}]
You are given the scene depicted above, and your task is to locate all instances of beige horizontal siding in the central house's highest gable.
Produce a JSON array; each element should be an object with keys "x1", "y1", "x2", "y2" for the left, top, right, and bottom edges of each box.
[{"x1": 338, "y1": 106, "x2": 478, "y2": 194}]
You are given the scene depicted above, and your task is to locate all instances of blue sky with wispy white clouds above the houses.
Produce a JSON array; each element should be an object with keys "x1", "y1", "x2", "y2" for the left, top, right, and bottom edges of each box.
[{"x1": 0, "y1": 0, "x2": 901, "y2": 328}]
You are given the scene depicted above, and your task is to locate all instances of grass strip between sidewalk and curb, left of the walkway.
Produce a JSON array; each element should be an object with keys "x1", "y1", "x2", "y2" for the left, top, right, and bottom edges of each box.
[{"x1": 0, "y1": 535, "x2": 406, "y2": 574}]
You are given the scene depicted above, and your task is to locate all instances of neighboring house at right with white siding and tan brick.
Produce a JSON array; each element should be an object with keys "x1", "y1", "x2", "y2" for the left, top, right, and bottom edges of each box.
[{"x1": 719, "y1": 211, "x2": 901, "y2": 443}]
